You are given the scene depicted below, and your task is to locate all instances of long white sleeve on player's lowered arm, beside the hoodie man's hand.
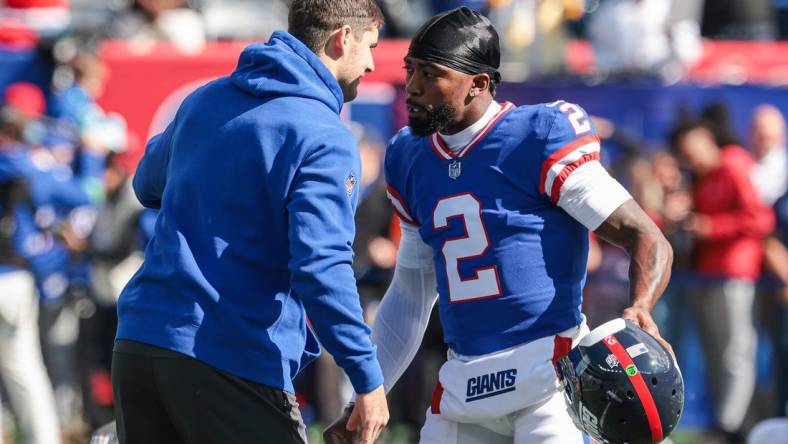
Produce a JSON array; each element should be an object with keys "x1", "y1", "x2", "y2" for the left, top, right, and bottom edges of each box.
[{"x1": 354, "y1": 222, "x2": 438, "y2": 399}]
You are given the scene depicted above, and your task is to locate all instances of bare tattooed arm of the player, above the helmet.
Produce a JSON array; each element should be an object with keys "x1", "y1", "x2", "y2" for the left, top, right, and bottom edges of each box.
[{"x1": 595, "y1": 199, "x2": 673, "y2": 310}]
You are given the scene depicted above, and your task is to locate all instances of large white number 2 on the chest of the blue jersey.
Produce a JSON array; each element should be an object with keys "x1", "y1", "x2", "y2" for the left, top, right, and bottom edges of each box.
[{"x1": 433, "y1": 193, "x2": 501, "y2": 303}]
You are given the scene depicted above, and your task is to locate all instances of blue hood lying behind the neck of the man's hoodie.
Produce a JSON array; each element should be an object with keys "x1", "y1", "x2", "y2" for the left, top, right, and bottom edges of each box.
[{"x1": 231, "y1": 31, "x2": 344, "y2": 114}]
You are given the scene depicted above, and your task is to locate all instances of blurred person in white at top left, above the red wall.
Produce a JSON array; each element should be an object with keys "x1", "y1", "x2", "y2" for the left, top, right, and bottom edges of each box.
[{"x1": 110, "y1": 0, "x2": 206, "y2": 53}]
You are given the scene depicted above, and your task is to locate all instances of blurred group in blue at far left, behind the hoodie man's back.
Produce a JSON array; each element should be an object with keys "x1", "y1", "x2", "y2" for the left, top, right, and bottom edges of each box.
[{"x1": 0, "y1": 53, "x2": 155, "y2": 443}]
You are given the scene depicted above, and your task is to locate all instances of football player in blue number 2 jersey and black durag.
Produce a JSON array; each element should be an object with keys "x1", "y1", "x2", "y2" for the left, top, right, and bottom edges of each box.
[{"x1": 324, "y1": 8, "x2": 672, "y2": 444}]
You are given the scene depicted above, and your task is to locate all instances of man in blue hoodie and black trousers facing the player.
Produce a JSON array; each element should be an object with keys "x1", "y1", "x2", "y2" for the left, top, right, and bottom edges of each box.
[{"x1": 112, "y1": 0, "x2": 388, "y2": 443}]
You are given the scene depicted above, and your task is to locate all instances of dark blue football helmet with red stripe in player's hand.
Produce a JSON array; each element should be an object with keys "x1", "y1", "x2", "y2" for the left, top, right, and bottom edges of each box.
[{"x1": 556, "y1": 319, "x2": 684, "y2": 444}]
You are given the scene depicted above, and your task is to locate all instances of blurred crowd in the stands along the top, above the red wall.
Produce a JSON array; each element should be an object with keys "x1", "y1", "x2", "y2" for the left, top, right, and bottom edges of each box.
[{"x1": 0, "y1": 0, "x2": 788, "y2": 81}]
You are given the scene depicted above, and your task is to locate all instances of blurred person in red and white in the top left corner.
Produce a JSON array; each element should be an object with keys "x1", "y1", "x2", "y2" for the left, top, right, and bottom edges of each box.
[{"x1": 0, "y1": 0, "x2": 71, "y2": 39}]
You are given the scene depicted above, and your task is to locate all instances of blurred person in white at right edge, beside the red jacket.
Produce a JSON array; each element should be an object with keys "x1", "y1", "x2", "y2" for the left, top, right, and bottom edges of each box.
[{"x1": 752, "y1": 105, "x2": 788, "y2": 205}]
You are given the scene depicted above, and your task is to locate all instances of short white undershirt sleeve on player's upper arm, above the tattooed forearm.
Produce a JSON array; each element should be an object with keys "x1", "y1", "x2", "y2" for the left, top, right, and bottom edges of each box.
[{"x1": 558, "y1": 161, "x2": 632, "y2": 231}]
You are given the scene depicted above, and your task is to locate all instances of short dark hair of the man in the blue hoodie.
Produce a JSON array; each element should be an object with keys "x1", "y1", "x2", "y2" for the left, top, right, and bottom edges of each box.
[{"x1": 287, "y1": 0, "x2": 384, "y2": 53}]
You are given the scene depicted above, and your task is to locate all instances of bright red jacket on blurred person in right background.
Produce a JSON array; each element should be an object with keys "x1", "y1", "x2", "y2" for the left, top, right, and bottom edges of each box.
[{"x1": 694, "y1": 145, "x2": 774, "y2": 280}]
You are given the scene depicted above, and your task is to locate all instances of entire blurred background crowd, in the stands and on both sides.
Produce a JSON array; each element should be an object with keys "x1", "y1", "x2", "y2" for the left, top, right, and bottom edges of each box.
[{"x1": 0, "y1": 0, "x2": 788, "y2": 443}]
